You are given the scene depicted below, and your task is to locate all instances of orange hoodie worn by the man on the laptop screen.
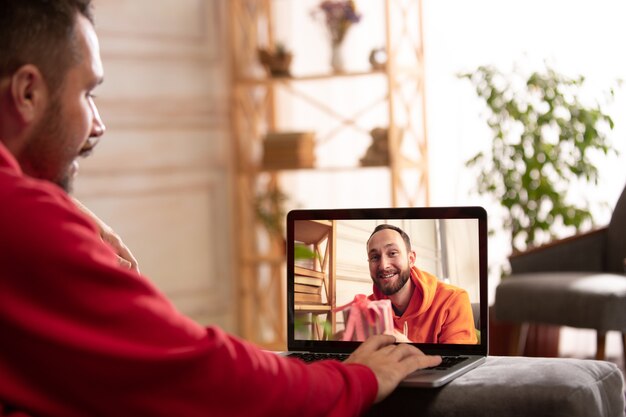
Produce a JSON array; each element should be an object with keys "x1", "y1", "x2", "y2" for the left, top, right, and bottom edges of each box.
[{"x1": 369, "y1": 267, "x2": 478, "y2": 344}]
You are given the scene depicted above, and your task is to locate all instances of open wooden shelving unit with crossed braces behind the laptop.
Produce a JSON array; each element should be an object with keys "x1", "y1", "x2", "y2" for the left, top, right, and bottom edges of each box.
[{"x1": 228, "y1": 0, "x2": 429, "y2": 349}]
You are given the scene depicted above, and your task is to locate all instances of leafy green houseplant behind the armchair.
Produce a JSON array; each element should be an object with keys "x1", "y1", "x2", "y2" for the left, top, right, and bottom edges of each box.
[{"x1": 459, "y1": 66, "x2": 616, "y2": 252}]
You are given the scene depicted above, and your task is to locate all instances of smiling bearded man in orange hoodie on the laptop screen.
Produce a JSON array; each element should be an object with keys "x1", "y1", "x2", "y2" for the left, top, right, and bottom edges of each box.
[{"x1": 367, "y1": 224, "x2": 478, "y2": 344}]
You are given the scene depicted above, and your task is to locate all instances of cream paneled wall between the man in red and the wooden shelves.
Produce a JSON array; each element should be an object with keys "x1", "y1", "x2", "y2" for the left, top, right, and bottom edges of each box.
[{"x1": 75, "y1": 0, "x2": 236, "y2": 331}]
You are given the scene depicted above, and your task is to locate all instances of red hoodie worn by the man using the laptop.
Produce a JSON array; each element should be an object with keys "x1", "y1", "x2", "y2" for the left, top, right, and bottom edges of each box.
[{"x1": 0, "y1": 142, "x2": 377, "y2": 417}]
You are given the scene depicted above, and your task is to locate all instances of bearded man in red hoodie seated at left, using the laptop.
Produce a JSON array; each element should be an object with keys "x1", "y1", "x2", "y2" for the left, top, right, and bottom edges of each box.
[{"x1": 0, "y1": 0, "x2": 441, "y2": 417}]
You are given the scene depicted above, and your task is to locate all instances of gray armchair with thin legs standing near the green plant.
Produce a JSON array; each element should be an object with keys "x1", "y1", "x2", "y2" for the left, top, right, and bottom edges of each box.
[{"x1": 494, "y1": 182, "x2": 626, "y2": 359}]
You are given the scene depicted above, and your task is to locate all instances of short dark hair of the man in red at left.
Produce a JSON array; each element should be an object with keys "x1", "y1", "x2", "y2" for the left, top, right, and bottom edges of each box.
[{"x1": 0, "y1": 0, "x2": 93, "y2": 92}]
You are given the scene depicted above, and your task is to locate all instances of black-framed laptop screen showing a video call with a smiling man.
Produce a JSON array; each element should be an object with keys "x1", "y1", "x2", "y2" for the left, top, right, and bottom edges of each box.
[{"x1": 287, "y1": 207, "x2": 488, "y2": 355}]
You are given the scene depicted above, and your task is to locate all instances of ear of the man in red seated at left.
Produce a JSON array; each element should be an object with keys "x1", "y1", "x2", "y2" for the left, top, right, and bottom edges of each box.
[{"x1": 11, "y1": 64, "x2": 48, "y2": 124}]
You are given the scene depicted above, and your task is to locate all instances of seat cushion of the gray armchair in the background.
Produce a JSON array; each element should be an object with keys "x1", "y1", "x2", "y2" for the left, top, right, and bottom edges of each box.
[{"x1": 495, "y1": 272, "x2": 626, "y2": 332}]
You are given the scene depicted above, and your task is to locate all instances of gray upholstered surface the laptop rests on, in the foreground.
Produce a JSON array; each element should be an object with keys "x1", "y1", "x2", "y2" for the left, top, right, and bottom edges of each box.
[{"x1": 367, "y1": 357, "x2": 624, "y2": 417}]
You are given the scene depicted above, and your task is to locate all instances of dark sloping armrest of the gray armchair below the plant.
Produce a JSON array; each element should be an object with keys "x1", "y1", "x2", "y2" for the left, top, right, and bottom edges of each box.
[{"x1": 509, "y1": 227, "x2": 607, "y2": 274}]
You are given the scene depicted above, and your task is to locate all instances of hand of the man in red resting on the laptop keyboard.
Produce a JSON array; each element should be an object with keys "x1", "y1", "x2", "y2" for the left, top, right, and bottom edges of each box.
[{"x1": 345, "y1": 335, "x2": 441, "y2": 402}]
